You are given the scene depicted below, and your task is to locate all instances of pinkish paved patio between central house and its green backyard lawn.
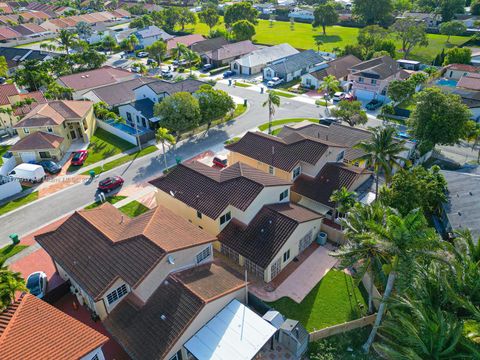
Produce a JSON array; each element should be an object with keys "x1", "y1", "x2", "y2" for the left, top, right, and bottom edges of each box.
[{"x1": 249, "y1": 244, "x2": 339, "y2": 303}]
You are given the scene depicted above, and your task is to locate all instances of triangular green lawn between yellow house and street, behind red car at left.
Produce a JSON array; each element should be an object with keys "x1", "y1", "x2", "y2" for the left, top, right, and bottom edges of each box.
[{"x1": 84, "y1": 128, "x2": 134, "y2": 166}]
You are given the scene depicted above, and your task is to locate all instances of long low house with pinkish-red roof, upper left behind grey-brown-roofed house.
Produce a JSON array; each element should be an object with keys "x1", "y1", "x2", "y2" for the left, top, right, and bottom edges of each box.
[{"x1": 57, "y1": 66, "x2": 139, "y2": 99}]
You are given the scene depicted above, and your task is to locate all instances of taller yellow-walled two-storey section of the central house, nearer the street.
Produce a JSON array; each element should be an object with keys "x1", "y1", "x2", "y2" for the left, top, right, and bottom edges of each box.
[{"x1": 150, "y1": 162, "x2": 291, "y2": 235}]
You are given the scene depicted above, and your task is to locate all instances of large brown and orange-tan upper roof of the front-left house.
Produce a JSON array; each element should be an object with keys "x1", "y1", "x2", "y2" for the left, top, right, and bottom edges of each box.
[{"x1": 36, "y1": 203, "x2": 215, "y2": 299}]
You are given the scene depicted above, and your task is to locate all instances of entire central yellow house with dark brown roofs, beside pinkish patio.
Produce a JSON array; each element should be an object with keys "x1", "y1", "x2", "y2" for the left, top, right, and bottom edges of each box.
[{"x1": 150, "y1": 162, "x2": 322, "y2": 282}]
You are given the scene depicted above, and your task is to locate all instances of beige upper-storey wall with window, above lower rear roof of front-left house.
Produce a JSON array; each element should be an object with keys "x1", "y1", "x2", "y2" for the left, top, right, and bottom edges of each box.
[{"x1": 133, "y1": 244, "x2": 213, "y2": 302}]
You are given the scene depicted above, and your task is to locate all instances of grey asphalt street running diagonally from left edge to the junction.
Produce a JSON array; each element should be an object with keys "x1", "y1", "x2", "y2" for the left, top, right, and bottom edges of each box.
[{"x1": 0, "y1": 84, "x2": 323, "y2": 247}]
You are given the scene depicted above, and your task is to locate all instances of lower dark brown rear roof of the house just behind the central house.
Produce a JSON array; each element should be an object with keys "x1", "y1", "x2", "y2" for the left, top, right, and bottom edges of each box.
[{"x1": 292, "y1": 163, "x2": 371, "y2": 207}]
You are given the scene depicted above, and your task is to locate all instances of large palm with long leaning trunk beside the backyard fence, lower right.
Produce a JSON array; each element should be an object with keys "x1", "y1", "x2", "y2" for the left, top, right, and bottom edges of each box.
[{"x1": 362, "y1": 209, "x2": 440, "y2": 353}]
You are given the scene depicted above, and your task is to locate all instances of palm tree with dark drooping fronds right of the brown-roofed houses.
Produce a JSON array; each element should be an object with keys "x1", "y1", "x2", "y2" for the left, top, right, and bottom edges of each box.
[{"x1": 354, "y1": 127, "x2": 408, "y2": 197}]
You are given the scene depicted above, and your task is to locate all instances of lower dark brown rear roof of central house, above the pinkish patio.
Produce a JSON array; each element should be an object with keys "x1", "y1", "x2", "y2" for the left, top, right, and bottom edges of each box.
[{"x1": 218, "y1": 204, "x2": 322, "y2": 268}]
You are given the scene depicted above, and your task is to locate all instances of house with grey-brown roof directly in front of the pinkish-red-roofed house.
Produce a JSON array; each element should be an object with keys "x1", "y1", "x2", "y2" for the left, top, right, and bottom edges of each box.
[{"x1": 83, "y1": 76, "x2": 158, "y2": 109}]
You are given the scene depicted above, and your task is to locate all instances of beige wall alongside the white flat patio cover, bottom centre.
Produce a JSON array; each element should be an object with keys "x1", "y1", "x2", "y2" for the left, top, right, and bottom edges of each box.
[{"x1": 165, "y1": 288, "x2": 246, "y2": 360}]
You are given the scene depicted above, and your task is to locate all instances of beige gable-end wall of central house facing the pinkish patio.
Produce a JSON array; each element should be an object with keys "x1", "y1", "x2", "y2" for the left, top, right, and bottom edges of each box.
[{"x1": 264, "y1": 219, "x2": 322, "y2": 282}]
